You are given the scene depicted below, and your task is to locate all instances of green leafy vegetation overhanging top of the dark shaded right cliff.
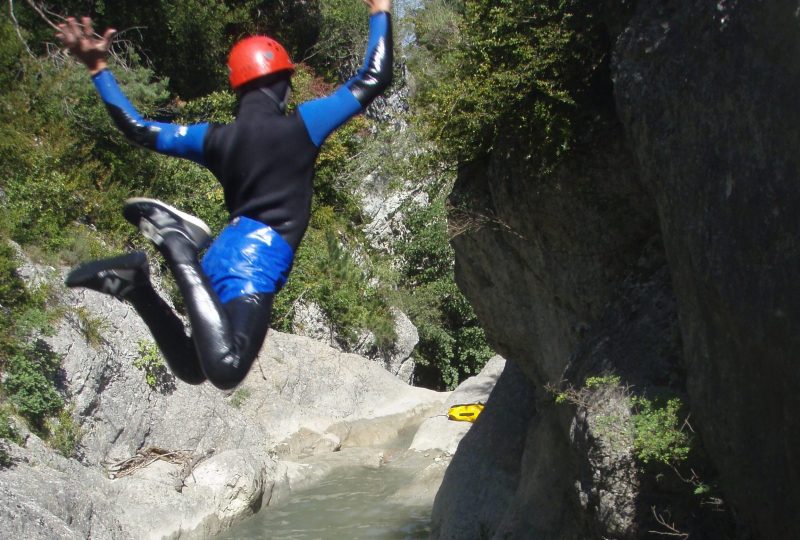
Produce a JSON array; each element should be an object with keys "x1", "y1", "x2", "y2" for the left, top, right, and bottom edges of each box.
[{"x1": 412, "y1": 0, "x2": 632, "y2": 167}]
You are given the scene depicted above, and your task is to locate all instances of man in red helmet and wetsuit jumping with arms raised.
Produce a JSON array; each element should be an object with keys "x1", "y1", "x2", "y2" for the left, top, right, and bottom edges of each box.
[{"x1": 57, "y1": 0, "x2": 392, "y2": 389}]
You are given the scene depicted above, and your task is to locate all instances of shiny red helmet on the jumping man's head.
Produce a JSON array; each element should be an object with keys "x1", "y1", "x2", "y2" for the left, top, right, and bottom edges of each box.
[{"x1": 228, "y1": 36, "x2": 294, "y2": 90}]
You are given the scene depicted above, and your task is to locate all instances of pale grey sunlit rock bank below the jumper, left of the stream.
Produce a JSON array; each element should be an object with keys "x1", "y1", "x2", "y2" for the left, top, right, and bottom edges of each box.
[{"x1": 0, "y1": 266, "x2": 445, "y2": 538}]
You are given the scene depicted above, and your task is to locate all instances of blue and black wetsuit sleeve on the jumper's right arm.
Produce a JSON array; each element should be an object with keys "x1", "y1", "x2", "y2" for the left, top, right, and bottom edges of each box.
[{"x1": 297, "y1": 12, "x2": 392, "y2": 147}]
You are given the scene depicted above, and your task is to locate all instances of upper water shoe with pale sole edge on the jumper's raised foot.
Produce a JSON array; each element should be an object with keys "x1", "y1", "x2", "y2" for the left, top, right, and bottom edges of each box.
[{"x1": 122, "y1": 197, "x2": 211, "y2": 251}]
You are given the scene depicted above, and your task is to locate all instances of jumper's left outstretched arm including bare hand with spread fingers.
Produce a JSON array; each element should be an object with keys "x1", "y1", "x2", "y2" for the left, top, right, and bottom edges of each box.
[{"x1": 56, "y1": 17, "x2": 208, "y2": 165}]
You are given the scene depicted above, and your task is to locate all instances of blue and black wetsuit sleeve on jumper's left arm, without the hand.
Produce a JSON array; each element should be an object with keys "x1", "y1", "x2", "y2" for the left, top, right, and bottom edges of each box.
[{"x1": 92, "y1": 70, "x2": 208, "y2": 165}]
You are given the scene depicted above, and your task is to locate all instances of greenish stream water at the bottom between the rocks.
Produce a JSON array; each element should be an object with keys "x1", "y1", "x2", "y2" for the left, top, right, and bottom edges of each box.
[{"x1": 220, "y1": 466, "x2": 431, "y2": 540}]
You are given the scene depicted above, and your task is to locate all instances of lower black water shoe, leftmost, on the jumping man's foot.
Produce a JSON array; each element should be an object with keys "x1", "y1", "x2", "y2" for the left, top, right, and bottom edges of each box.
[{"x1": 65, "y1": 251, "x2": 150, "y2": 299}]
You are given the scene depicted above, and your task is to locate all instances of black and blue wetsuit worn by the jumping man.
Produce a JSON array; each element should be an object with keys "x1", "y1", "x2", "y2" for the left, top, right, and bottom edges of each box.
[{"x1": 93, "y1": 12, "x2": 392, "y2": 389}]
